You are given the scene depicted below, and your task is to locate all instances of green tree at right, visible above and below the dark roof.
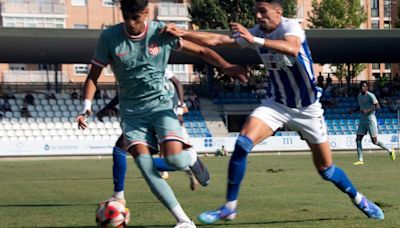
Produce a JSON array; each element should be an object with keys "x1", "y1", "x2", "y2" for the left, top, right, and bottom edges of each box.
[{"x1": 308, "y1": 0, "x2": 367, "y2": 89}]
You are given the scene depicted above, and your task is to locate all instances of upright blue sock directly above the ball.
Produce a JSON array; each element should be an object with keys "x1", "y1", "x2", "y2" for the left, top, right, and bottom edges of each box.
[{"x1": 113, "y1": 147, "x2": 126, "y2": 192}]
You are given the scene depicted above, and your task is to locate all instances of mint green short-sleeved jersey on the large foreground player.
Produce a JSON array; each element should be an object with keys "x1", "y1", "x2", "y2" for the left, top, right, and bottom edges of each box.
[{"x1": 92, "y1": 21, "x2": 180, "y2": 118}]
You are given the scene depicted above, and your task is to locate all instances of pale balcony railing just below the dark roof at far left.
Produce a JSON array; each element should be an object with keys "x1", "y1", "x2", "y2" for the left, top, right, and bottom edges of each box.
[{"x1": 3, "y1": 70, "x2": 69, "y2": 83}]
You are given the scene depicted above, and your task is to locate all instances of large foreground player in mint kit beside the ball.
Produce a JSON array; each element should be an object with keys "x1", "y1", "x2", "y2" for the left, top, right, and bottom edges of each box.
[{"x1": 77, "y1": 0, "x2": 246, "y2": 227}]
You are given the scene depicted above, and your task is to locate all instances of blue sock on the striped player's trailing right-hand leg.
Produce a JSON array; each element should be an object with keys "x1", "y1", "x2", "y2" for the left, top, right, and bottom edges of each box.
[{"x1": 319, "y1": 165, "x2": 357, "y2": 199}]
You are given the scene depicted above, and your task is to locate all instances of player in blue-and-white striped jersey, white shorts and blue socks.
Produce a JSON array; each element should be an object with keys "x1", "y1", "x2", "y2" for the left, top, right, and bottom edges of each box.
[{"x1": 166, "y1": 0, "x2": 384, "y2": 224}]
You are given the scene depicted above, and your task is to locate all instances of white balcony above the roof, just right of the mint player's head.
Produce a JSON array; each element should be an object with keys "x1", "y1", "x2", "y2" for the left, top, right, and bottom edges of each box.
[{"x1": 157, "y1": 3, "x2": 191, "y2": 21}]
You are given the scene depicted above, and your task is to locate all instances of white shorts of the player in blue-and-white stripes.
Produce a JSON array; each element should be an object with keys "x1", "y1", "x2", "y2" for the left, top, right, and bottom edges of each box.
[{"x1": 250, "y1": 99, "x2": 328, "y2": 144}]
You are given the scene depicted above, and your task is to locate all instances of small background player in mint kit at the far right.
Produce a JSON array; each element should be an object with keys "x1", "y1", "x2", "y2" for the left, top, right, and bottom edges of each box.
[{"x1": 350, "y1": 81, "x2": 396, "y2": 165}]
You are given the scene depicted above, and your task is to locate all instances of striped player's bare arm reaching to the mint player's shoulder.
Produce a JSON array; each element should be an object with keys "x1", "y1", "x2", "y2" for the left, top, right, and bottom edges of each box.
[{"x1": 162, "y1": 23, "x2": 237, "y2": 46}]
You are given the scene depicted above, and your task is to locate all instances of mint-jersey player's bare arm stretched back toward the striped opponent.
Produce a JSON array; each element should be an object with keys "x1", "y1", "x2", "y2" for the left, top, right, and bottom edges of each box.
[{"x1": 181, "y1": 40, "x2": 247, "y2": 82}]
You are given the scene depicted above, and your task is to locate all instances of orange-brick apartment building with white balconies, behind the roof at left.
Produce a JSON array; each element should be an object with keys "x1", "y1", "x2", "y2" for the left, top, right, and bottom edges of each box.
[{"x1": 0, "y1": 0, "x2": 197, "y2": 82}]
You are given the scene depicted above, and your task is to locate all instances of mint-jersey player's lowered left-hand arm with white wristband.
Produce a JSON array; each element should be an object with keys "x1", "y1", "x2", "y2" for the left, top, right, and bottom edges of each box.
[{"x1": 76, "y1": 65, "x2": 103, "y2": 129}]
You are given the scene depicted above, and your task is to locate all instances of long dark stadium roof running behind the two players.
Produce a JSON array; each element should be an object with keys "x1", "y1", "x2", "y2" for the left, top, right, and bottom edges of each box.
[{"x1": 0, "y1": 28, "x2": 400, "y2": 64}]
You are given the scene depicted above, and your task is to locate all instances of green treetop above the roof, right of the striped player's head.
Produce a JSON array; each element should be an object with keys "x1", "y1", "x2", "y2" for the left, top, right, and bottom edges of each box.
[{"x1": 308, "y1": 0, "x2": 367, "y2": 28}]
